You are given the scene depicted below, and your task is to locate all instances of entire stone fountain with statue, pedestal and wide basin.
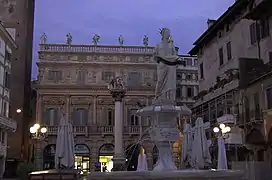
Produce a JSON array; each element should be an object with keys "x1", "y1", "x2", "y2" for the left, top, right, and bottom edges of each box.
[{"x1": 88, "y1": 28, "x2": 243, "y2": 180}]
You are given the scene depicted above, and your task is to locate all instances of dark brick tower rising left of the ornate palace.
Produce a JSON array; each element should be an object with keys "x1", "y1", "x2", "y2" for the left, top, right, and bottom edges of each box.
[{"x1": 0, "y1": 0, "x2": 35, "y2": 162}]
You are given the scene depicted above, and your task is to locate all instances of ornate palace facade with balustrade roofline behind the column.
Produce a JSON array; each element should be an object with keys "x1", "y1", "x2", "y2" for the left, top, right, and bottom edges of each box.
[{"x1": 32, "y1": 36, "x2": 198, "y2": 171}]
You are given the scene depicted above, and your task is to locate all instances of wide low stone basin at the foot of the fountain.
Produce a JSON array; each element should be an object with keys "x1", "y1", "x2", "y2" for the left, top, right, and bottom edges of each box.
[{"x1": 87, "y1": 170, "x2": 243, "y2": 180}]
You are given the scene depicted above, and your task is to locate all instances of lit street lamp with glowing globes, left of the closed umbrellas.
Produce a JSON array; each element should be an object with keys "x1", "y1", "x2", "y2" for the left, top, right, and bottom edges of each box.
[{"x1": 29, "y1": 123, "x2": 47, "y2": 163}]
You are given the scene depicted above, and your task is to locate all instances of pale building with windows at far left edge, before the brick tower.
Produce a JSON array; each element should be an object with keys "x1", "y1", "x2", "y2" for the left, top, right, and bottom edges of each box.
[{"x1": 0, "y1": 23, "x2": 17, "y2": 177}]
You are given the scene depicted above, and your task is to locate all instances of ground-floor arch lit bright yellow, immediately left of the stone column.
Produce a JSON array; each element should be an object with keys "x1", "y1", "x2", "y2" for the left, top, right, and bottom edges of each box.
[{"x1": 96, "y1": 143, "x2": 114, "y2": 172}]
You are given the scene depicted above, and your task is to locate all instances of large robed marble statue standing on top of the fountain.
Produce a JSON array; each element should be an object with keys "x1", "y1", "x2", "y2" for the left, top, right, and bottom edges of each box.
[{"x1": 154, "y1": 28, "x2": 182, "y2": 101}]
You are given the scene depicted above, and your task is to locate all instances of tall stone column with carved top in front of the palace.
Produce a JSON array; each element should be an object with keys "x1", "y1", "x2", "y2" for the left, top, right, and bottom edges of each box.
[{"x1": 109, "y1": 79, "x2": 126, "y2": 171}]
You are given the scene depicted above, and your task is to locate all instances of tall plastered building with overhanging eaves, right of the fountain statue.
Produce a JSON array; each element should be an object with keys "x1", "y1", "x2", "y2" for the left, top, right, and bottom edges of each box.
[{"x1": 189, "y1": 0, "x2": 272, "y2": 165}]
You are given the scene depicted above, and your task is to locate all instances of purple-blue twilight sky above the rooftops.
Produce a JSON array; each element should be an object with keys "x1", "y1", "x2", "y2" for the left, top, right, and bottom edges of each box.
[{"x1": 32, "y1": 0, "x2": 235, "y2": 79}]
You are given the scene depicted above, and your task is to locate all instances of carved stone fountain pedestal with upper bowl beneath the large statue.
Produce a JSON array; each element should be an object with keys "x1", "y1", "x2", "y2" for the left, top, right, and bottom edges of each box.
[{"x1": 137, "y1": 101, "x2": 182, "y2": 171}]
